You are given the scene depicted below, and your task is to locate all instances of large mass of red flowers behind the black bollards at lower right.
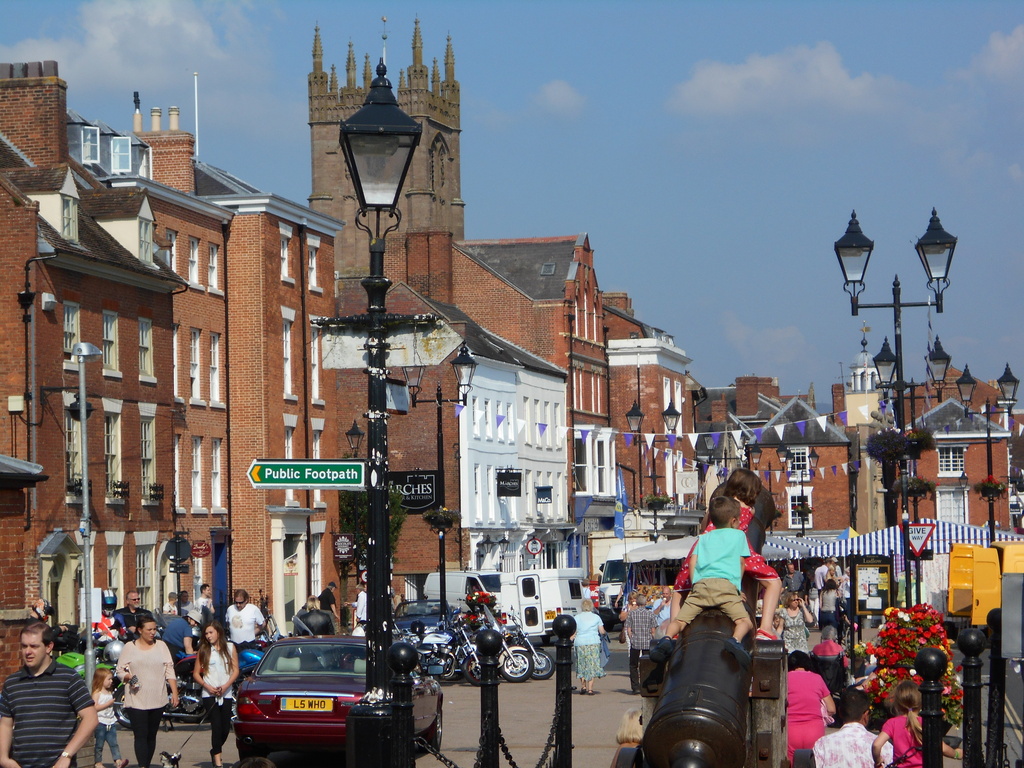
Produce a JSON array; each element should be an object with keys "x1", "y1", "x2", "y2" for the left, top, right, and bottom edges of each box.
[{"x1": 864, "y1": 605, "x2": 964, "y2": 725}]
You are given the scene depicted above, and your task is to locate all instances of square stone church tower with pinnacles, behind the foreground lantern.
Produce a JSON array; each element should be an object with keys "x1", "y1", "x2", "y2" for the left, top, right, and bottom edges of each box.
[{"x1": 309, "y1": 19, "x2": 465, "y2": 279}]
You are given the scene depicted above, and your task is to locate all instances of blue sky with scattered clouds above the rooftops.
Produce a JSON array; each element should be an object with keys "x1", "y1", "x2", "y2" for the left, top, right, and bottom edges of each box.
[{"x1": 0, "y1": 0, "x2": 1024, "y2": 412}]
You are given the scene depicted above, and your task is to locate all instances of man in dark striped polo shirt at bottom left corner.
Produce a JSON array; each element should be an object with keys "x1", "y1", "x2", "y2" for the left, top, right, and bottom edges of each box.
[{"x1": 0, "y1": 622, "x2": 97, "y2": 768}]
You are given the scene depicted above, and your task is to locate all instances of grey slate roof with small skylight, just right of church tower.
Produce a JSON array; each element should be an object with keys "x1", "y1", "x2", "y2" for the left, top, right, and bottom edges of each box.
[{"x1": 455, "y1": 234, "x2": 586, "y2": 300}]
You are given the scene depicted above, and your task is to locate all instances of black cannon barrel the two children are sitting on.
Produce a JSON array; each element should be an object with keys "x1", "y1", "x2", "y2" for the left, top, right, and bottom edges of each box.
[{"x1": 644, "y1": 610, "x2": 751, "y2": 768}]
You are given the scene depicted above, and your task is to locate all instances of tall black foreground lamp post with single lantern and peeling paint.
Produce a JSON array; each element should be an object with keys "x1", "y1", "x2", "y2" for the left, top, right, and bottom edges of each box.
[{"x1": 323, "y1": 59, "x2": 423, "y2": 767}]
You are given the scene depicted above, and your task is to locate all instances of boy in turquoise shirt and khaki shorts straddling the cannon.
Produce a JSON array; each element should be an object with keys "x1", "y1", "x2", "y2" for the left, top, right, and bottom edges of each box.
[{"x1": 666, "y1": 496, "x2": 754, "y2": 667}]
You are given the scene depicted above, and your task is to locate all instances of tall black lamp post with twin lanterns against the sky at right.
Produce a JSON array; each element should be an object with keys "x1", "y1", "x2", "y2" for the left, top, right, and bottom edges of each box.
[{"x1": 835, "y1": 208, "x2": 956, "y2": 605}]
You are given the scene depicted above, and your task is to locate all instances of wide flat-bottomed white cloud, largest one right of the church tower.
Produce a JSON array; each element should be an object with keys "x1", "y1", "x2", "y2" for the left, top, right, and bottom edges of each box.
[{"x1": 667, "y1": 42, "x2": 902, "y2": 116}]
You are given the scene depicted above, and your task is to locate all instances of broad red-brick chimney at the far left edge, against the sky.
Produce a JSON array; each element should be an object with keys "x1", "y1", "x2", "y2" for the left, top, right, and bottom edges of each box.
[{"x1": 0, "y1": 61, "x2": 68, "y2": 168}]
